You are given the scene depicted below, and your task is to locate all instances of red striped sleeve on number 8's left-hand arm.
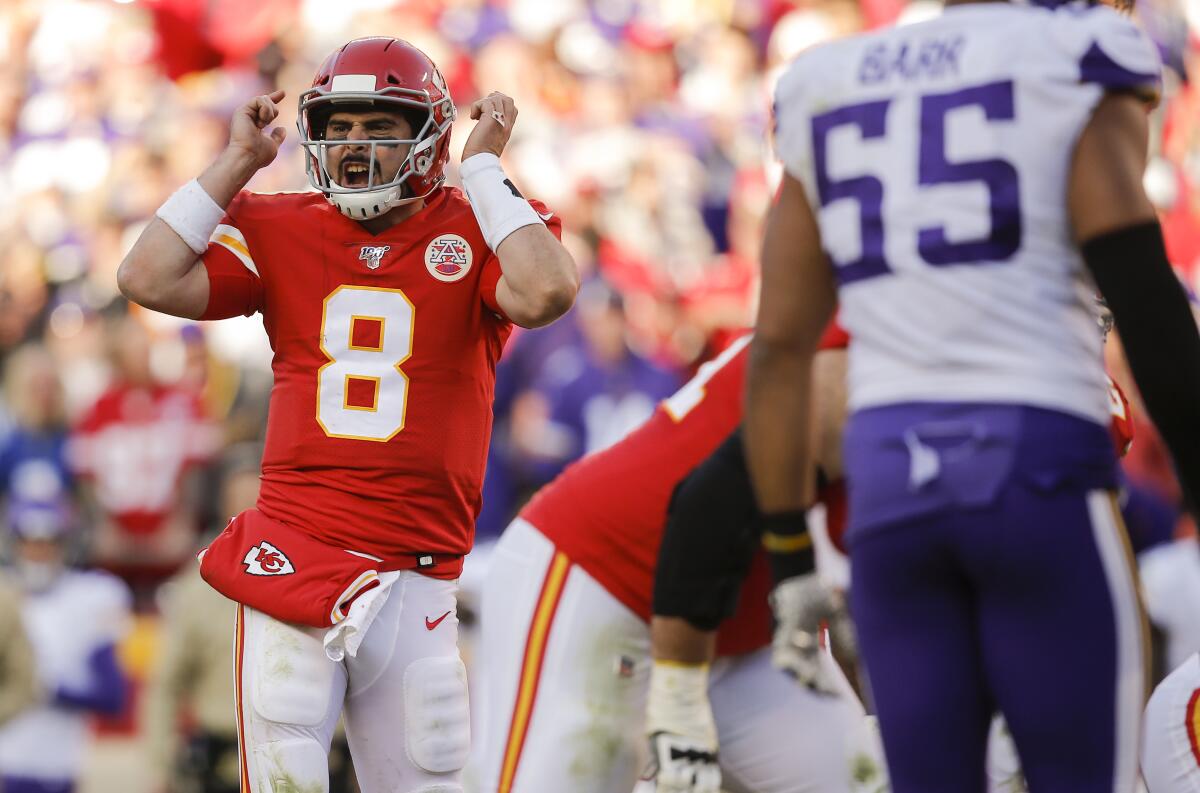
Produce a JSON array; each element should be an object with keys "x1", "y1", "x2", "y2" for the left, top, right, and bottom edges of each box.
[{"x1": 200, "y1": 192, "x2": 263, "y2": 319}]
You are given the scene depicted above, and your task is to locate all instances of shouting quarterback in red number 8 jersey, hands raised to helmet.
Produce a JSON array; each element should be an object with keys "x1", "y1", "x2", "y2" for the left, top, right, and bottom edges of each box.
[{"x1": 118, "y1": 37, "x2": 578, "y2": 793}]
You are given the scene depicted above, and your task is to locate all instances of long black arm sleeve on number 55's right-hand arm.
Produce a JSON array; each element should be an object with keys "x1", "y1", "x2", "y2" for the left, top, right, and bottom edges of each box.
[{"x1": 1082, "y1": 222, "x2": 1200, "y2": 509}]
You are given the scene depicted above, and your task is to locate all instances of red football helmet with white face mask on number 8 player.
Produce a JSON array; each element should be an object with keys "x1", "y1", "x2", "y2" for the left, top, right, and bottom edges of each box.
[{"x1": 296, "y1": 36, "x2": 455, "y2": 221}]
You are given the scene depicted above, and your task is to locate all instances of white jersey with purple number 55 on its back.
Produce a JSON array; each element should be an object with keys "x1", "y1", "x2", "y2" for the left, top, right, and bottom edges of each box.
[{"x1": 775, "y1": 2, "x2": 1162, "y2": 423}]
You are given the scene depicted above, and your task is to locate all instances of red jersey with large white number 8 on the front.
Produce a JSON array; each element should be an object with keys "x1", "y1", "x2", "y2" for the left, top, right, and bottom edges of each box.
[{"x1": 203, "y1": 187, "x2": 562, "y2": 578}]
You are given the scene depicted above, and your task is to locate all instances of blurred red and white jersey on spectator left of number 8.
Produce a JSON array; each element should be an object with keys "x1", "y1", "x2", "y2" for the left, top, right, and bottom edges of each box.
[{"x1": 70, "y1": 384, "x2": 220, "y2": 534}]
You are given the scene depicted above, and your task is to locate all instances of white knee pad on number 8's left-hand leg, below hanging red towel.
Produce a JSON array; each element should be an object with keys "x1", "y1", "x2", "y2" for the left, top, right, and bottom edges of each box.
[{"x1": 252, "y1": 618, "x2": 334, "y2": 724}]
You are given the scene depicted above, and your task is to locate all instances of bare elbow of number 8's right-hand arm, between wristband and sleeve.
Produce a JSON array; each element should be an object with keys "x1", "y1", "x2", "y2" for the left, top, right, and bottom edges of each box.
[{"x1": 496, "y1": 224, "x2": 580, "y2": 328}]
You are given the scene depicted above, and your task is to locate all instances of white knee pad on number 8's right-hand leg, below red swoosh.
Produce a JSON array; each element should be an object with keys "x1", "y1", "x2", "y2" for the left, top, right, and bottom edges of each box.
[{"x1": 404, "y1": 657, "x2": 470, "y2": 772}]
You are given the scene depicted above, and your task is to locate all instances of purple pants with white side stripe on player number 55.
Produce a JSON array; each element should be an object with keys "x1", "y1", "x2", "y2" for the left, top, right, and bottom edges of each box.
[{"x1": 846, "y1": 404, "x2": 1145, "y2": 793}]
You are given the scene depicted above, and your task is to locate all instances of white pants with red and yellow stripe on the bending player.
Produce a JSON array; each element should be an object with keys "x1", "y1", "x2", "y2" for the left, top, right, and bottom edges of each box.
[{"x1": 473, "y1": 518, "x2": 886, "y2": 793}]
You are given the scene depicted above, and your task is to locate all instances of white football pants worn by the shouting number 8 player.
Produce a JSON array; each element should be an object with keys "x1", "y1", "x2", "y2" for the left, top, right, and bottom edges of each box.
[{"x1": 234, "y1": 571, "x2": 470, "y2": 793}]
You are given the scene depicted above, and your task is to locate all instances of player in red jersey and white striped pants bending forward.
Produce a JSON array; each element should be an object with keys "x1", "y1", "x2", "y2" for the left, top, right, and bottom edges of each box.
[{"x1": 479, "y1": 328, "x2": 883, "y2": 793}]
